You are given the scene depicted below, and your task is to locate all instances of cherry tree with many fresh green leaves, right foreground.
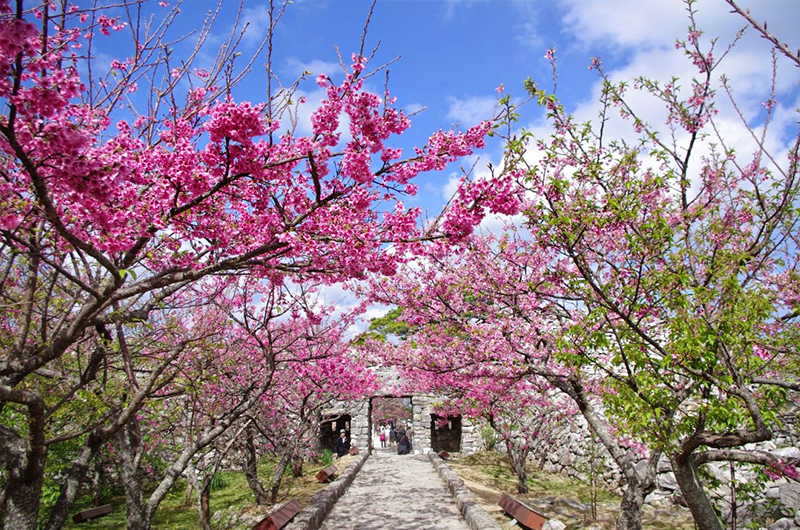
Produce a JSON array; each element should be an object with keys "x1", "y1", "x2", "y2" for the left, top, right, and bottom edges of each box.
[{"x1": 511, "y1": 8, "x2": 800, "y2": 530}]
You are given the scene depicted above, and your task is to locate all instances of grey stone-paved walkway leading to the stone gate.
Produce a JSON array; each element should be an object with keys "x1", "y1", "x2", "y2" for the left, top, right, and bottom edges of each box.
[{"x1": 321, "y1": 449, "x2": 469, "y2": 530}]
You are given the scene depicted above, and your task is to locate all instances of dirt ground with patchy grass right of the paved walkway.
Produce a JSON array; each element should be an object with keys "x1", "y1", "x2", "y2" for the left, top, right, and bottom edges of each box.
[{"x1": 440, "y1": 452, "x2": 695, "y2": 530}]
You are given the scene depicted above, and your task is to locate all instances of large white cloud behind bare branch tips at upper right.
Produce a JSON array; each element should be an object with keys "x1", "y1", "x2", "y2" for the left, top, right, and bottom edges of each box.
[{"x1": 529, "y1": 0, "x2": 800, "y2": 191}]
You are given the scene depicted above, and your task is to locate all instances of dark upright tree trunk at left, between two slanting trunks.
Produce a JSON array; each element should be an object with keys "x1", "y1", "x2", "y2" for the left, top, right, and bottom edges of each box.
[{"x1": 115, "y1": 418, "x2": 150, "y2": 530}]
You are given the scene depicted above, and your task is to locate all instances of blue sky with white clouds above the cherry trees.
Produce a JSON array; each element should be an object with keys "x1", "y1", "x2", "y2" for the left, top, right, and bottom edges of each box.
[{"x1": 89, "y1": 0, "x2": 800, "y2": 330}]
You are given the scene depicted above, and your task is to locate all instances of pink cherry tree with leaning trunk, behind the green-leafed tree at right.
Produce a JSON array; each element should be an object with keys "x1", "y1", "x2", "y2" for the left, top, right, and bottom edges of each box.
[{"x1": 369, "y1": 235, "x2": 660, "y2": 529}]
